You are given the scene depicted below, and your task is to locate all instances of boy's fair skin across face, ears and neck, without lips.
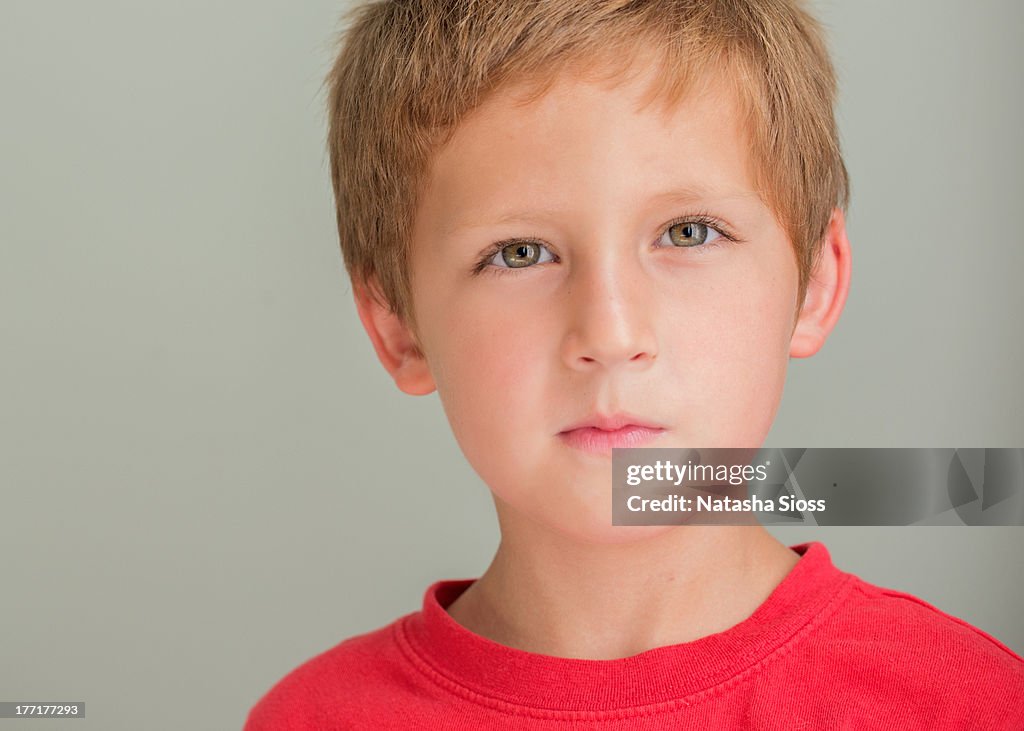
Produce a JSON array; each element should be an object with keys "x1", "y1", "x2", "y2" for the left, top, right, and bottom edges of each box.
[{"x1": 355, "y1": 56, "x2": 850, "y2": 659}]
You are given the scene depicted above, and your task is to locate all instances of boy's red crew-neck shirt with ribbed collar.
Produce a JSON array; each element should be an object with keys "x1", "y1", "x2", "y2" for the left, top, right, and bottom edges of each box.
[{"x1": 245, "y1": 543, "x2": 1024, "y2": 731}]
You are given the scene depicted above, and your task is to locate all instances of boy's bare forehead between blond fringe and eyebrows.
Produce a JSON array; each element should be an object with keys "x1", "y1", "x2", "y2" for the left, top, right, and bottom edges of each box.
[{"x1": 413, "y1": 60, "x2": 761, "y2": 234}]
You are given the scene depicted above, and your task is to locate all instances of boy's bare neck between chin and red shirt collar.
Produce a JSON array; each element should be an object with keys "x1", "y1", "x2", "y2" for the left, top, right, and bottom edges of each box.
[{"x1": 447, "y1": 497, "x2": 799, "y2": 659}]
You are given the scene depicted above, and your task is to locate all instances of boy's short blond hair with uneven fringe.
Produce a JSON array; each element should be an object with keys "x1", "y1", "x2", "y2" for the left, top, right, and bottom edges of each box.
[{"x1": 325, "y1": 0, "x2": 849, "y2": 328}]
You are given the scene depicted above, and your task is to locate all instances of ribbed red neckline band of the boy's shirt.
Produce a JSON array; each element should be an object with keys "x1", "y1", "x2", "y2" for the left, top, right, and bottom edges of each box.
[{"x1": 398, "y1": 542, "x2": 853, "y2": 712}]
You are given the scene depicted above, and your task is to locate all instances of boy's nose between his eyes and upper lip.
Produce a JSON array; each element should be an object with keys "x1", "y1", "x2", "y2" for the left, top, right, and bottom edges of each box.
[{"x1": 562, "y1": 247, "x2": 657, "y2": 371}]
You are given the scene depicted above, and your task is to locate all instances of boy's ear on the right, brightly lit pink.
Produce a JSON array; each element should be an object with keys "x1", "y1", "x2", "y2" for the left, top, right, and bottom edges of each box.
[{"x1": 790, "y1": 208, "x2": 850, "y2": 358}]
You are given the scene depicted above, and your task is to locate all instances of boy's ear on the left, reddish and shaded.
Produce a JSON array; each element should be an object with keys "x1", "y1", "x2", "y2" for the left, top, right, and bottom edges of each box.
[{"x1": 352, "y1": 283, "x2": 436, "y2": 396}]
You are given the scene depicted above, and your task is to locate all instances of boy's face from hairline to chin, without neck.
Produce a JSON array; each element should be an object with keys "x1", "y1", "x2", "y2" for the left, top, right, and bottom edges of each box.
[{"x1": 365, "y1": 56, "x2": 839, "y2": 541}]
